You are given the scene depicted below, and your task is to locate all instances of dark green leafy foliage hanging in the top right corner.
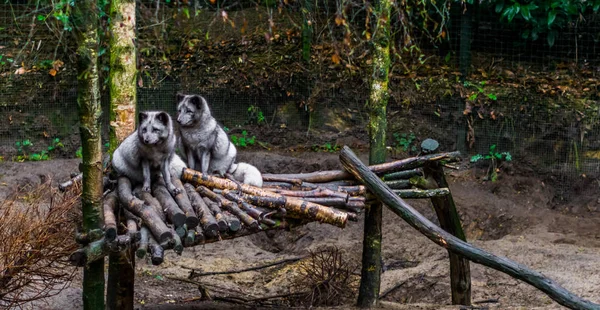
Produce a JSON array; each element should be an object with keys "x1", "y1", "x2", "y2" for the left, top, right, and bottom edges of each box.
[{"x1": 488, "y1": 0, "x2": 600, "y2": 47}]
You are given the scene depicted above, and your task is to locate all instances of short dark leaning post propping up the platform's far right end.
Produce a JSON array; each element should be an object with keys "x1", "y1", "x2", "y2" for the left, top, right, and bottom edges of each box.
[{"x1": 424, "y1": 163, "x2": 471, "y2": 305}]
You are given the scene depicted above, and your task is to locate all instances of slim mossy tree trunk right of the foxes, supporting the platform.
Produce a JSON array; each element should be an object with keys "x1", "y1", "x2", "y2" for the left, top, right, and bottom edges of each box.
[{"x1": 358, "y1": 0, "x2": 392, "y2": 308}]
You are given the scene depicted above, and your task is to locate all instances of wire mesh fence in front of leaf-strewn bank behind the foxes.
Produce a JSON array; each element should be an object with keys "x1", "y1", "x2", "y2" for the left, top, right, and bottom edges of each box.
[{"x1": 0, "y1": 0, "x2": 600, "y2": 199}]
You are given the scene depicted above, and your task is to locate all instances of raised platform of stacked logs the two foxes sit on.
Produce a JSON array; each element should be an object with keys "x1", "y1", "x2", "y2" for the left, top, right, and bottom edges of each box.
[{"x1": 70, "y1": 152, "x2": 459, "y2": 266}]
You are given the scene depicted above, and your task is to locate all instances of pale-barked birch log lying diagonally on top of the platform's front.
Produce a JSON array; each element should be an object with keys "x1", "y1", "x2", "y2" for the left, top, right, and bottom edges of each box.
[{"x1": 182, "y1": 168, "x2": 349, "y2": 228}]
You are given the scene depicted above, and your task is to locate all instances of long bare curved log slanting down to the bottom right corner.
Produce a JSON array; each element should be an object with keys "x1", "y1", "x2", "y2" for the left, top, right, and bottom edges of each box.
[{"x1": 340, "y1": 146, "x2": 600, "y2": 309}]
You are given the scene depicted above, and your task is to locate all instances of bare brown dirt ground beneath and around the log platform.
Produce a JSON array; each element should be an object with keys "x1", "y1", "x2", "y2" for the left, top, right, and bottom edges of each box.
[{"x1": 0, "y1": 152, "x2": 600, "y2": 310}]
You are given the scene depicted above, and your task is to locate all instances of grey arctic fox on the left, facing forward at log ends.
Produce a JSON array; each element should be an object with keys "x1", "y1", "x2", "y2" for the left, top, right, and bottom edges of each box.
[{"x1": 112, "y1": 111, "x2": 185, "y2": 195}]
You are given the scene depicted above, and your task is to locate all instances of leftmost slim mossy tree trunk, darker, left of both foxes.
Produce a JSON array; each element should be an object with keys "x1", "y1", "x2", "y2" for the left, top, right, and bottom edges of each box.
[{"x1": 73, "y1": 1, "x2": 105, "y2": 309}]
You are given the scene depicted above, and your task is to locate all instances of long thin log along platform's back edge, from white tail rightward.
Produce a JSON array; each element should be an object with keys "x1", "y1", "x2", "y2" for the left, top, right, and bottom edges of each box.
[{"x1": 263, "y1": 152, "x2": 460, "y2": 183}]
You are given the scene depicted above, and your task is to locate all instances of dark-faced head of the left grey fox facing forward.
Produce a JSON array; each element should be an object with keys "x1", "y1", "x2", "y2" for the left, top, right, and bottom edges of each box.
[{"x1": 138, "y1": 111, "x2": 173, "y2": 145}]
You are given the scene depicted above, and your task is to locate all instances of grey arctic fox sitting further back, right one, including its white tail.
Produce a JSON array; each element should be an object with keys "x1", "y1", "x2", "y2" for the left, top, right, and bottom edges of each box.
[{"x1": 177, "y1": 93, "x2": 262, "y2": 187}]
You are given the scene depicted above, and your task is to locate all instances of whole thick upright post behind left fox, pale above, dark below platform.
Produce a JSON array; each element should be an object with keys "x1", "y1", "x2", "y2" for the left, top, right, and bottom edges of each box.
[{"x1": 107, "y1": 0, "x2": 137, "y2": 310}]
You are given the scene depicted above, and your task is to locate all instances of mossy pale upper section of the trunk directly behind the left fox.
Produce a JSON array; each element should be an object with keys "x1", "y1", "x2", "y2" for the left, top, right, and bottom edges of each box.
[{"x1": 108, "y1": 0, "x2": 137, "y2": 154}]
